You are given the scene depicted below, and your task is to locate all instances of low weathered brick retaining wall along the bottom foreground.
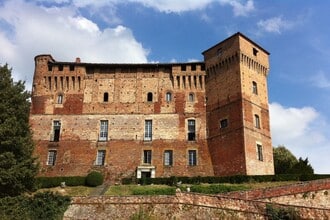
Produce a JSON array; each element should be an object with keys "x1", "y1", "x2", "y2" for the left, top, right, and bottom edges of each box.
[{"x1": 64, "y1": 193, "x2": 330, "y2": 220}]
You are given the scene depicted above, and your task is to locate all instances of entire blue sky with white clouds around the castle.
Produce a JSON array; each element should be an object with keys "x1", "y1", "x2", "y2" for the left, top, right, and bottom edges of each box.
[{"x1": 0, "y1": 0, "x2": 330, "y2": 173}]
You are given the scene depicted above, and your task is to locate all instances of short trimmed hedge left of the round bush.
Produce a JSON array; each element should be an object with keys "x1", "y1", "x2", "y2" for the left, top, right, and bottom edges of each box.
[{"x1": 36, "y1": 176, "x2": 86, "y2": 188}]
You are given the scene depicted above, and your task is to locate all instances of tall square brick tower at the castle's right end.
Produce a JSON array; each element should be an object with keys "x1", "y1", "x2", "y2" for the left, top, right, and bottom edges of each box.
[{"x1": 203, "y1": 33, "x2": 274, "y2": 176}]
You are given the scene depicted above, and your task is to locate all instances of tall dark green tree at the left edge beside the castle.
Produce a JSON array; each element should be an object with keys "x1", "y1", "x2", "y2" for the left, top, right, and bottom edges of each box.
[{"x1": 0, "y1": 64, "x2": 38, "y2": 197}]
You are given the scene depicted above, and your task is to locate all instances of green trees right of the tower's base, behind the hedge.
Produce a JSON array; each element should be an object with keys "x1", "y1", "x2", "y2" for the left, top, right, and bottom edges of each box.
[{"x1": 273, "y1": 146, "x2": 314, "y2": 175}]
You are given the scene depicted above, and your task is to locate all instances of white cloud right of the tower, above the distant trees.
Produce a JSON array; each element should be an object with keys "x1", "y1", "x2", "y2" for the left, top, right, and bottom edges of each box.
[{"x1": 269, "y1": 103, "x2": 330, "y2": 173}]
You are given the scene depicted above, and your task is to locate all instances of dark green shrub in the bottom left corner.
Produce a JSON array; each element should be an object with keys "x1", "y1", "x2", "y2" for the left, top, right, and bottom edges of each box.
[{"x1": 0, "y1": 192, "x2": 70, "y2": 220}]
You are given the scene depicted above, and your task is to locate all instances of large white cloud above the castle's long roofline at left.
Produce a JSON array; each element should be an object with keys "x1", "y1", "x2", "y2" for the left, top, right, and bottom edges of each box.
[{"x1": 0, "y1": 0, "x2": 148, "y2": 89}]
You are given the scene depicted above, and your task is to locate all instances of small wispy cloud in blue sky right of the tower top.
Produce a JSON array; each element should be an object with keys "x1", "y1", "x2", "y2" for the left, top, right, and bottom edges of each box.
[{"x1": 257, "y1": 16, "x2": 293, "y2": 34}]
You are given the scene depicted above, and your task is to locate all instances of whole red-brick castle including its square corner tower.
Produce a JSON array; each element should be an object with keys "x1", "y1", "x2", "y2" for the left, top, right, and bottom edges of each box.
[{"x1": 30, "y1": 32, "x2": 274, "y2": 181}]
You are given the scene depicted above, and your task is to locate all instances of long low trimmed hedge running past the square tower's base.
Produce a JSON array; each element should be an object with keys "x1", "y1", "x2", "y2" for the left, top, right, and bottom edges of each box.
[{"x1": 122, "y1": 174, "x2": 330, "y2": 186}]
